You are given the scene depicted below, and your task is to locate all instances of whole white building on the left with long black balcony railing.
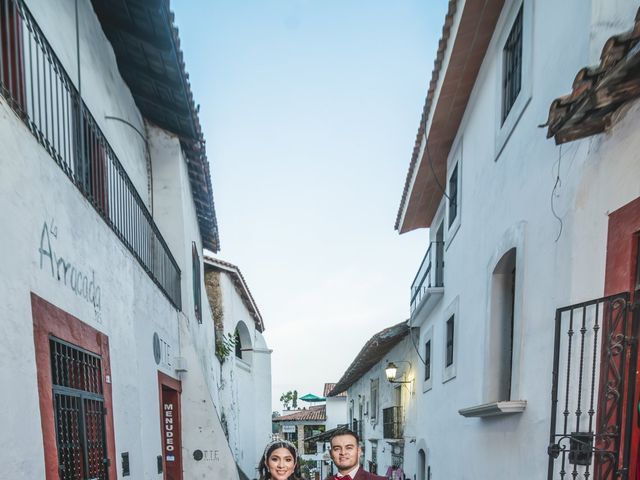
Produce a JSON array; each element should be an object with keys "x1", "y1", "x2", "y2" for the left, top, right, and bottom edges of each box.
[{"x1": 0, "y1": 0, "x2": 270, "y2": 479}]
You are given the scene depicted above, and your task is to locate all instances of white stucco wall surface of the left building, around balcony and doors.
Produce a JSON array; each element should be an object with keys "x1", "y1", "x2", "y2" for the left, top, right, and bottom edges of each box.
[{"x1": 0, "y1": 0, "x2": 237, "y2": 479}]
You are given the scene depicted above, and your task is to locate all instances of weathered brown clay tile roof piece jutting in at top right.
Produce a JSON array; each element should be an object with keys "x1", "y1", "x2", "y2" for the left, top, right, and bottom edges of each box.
[{"x1": 546, "y1": 8, "x2": 640, "y2": 144}]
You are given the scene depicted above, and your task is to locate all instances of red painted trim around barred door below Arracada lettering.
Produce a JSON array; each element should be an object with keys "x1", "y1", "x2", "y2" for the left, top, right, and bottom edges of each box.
[{"x1": 31, "y1": 293, "x2": 117, "y2": 480}]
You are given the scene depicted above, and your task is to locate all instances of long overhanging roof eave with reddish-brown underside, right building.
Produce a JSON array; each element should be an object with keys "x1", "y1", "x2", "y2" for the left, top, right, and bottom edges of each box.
[{"x1": 395, "y1": 0, "x2": 504, "y2": 233}]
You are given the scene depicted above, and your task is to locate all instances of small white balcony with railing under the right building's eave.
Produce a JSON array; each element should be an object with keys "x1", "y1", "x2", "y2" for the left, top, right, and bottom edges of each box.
[{"x1": 411, "y1": 241, "x2": 444, "y2": 316}]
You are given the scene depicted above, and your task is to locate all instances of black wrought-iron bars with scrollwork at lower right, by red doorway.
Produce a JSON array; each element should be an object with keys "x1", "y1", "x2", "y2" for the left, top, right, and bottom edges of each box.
[{"x1": 547, "y1": 293, "x2": 638, "y2": 480}]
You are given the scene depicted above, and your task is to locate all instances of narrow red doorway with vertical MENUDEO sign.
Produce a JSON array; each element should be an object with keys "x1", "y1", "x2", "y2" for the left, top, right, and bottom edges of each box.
[{"x1": 158, "y1": 371, "x2": 182, "y2": 480}]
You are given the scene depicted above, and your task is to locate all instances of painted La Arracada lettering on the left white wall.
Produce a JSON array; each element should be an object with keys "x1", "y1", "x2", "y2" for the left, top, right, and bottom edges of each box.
[{"x1": 38, "y1": 219, "x2": 102, "y2": 321}]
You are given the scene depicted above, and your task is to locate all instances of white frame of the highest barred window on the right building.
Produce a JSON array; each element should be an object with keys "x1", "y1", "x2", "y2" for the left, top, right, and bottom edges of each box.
[{"x1": 495, "y1": 0, "x2": 534, "y2": 161}]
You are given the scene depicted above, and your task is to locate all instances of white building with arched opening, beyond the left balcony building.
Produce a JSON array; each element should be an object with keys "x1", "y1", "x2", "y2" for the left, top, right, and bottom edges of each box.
[{"x1": 204, "y1": 256, "x2": 271, "y2": 478}]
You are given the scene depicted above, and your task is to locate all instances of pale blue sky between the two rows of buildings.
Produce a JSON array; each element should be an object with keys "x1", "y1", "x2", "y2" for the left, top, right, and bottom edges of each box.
[{"x1": 171, "y1": 0, "x2": 447, "y2": 410}]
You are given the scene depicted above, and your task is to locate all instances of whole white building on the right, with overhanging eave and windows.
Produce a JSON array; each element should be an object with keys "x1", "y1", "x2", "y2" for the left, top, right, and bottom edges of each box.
[{"x1": 396, "y1": 0, "x2": 640, "y2": 480}]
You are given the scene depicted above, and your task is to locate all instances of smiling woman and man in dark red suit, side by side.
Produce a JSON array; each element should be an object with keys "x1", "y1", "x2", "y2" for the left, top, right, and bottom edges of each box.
[{"x1": 258, "y1": 430, "x2": 386, "y2": 480}]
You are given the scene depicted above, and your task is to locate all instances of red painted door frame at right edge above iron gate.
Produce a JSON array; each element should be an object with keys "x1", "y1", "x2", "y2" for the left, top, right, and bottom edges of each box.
[{"x1": 604, "y1": 197, "x2": 640, "y2": 480}]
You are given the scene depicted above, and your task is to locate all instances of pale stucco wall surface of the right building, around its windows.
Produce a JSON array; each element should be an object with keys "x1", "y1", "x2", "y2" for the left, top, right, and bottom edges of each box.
[{"x1": 407, "y1": 0, "x2": 640, "y2": 479}]
